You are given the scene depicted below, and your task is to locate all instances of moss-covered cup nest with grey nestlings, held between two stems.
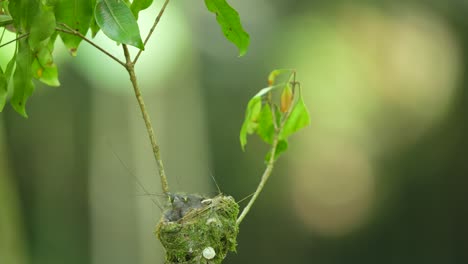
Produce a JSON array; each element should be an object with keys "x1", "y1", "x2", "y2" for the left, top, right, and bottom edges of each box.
[{"x1": 156, "y1": 194, "x2": 239, "y2": 264}]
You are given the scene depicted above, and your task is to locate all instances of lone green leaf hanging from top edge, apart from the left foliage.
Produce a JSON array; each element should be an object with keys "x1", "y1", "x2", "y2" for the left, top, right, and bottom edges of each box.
[{"x1": 205, "y1": 0, "x2": 250, "y2": 56}]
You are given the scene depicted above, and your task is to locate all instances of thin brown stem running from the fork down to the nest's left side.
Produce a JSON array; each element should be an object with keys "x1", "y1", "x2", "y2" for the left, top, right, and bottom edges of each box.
[{"x1": 122, "y1": 44, "x2": 169, "y2": 195}]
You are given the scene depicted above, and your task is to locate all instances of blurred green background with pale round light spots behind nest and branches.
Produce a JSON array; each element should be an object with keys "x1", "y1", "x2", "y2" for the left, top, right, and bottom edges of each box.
[{"x1": 0, "y1": 0, "x2": 468, "y2": 264}]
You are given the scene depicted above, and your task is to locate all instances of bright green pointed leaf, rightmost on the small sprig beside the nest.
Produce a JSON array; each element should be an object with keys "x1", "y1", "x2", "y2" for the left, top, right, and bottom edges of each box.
[{"x1": 280, "y1": 91, "x2": 310, "y2": 139}]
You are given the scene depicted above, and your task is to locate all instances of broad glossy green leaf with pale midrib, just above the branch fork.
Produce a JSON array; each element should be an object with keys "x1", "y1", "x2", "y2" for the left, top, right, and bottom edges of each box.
[{"x1": 95, "y1": 0, "x2": 144, "y2": 50}]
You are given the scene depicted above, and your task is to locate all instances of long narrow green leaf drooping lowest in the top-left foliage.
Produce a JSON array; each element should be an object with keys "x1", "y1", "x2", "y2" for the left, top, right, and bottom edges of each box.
[{"x1": 10, "y1": 39, "x2": 34, "y2": 118}]
